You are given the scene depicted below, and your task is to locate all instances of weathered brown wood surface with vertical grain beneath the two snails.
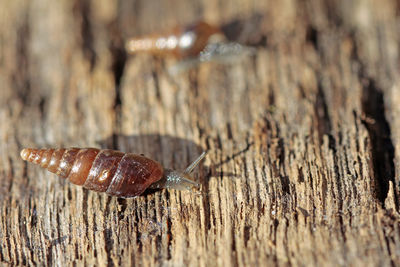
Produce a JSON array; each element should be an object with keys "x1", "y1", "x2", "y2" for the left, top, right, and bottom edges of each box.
[{"x1": 0, "y1": 0, "x2": 400, "y2": 266}]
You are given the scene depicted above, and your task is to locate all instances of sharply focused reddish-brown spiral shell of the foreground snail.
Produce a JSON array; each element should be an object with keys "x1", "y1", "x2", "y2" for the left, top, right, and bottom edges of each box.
[{"x1": 21, "y1": 148, "x2": 164, "y2": 197}]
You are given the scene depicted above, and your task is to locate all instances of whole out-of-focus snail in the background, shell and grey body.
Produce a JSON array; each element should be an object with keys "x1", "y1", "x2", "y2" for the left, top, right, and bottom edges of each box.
[{"x1": 125, "y1": 21, "x2": 255, "y2": 73}]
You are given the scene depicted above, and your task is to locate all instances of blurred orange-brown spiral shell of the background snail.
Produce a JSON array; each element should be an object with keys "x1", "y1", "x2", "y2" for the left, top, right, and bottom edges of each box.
[{"x1": 126, "y1": 22, "x2": 220, "y2": 58}]
